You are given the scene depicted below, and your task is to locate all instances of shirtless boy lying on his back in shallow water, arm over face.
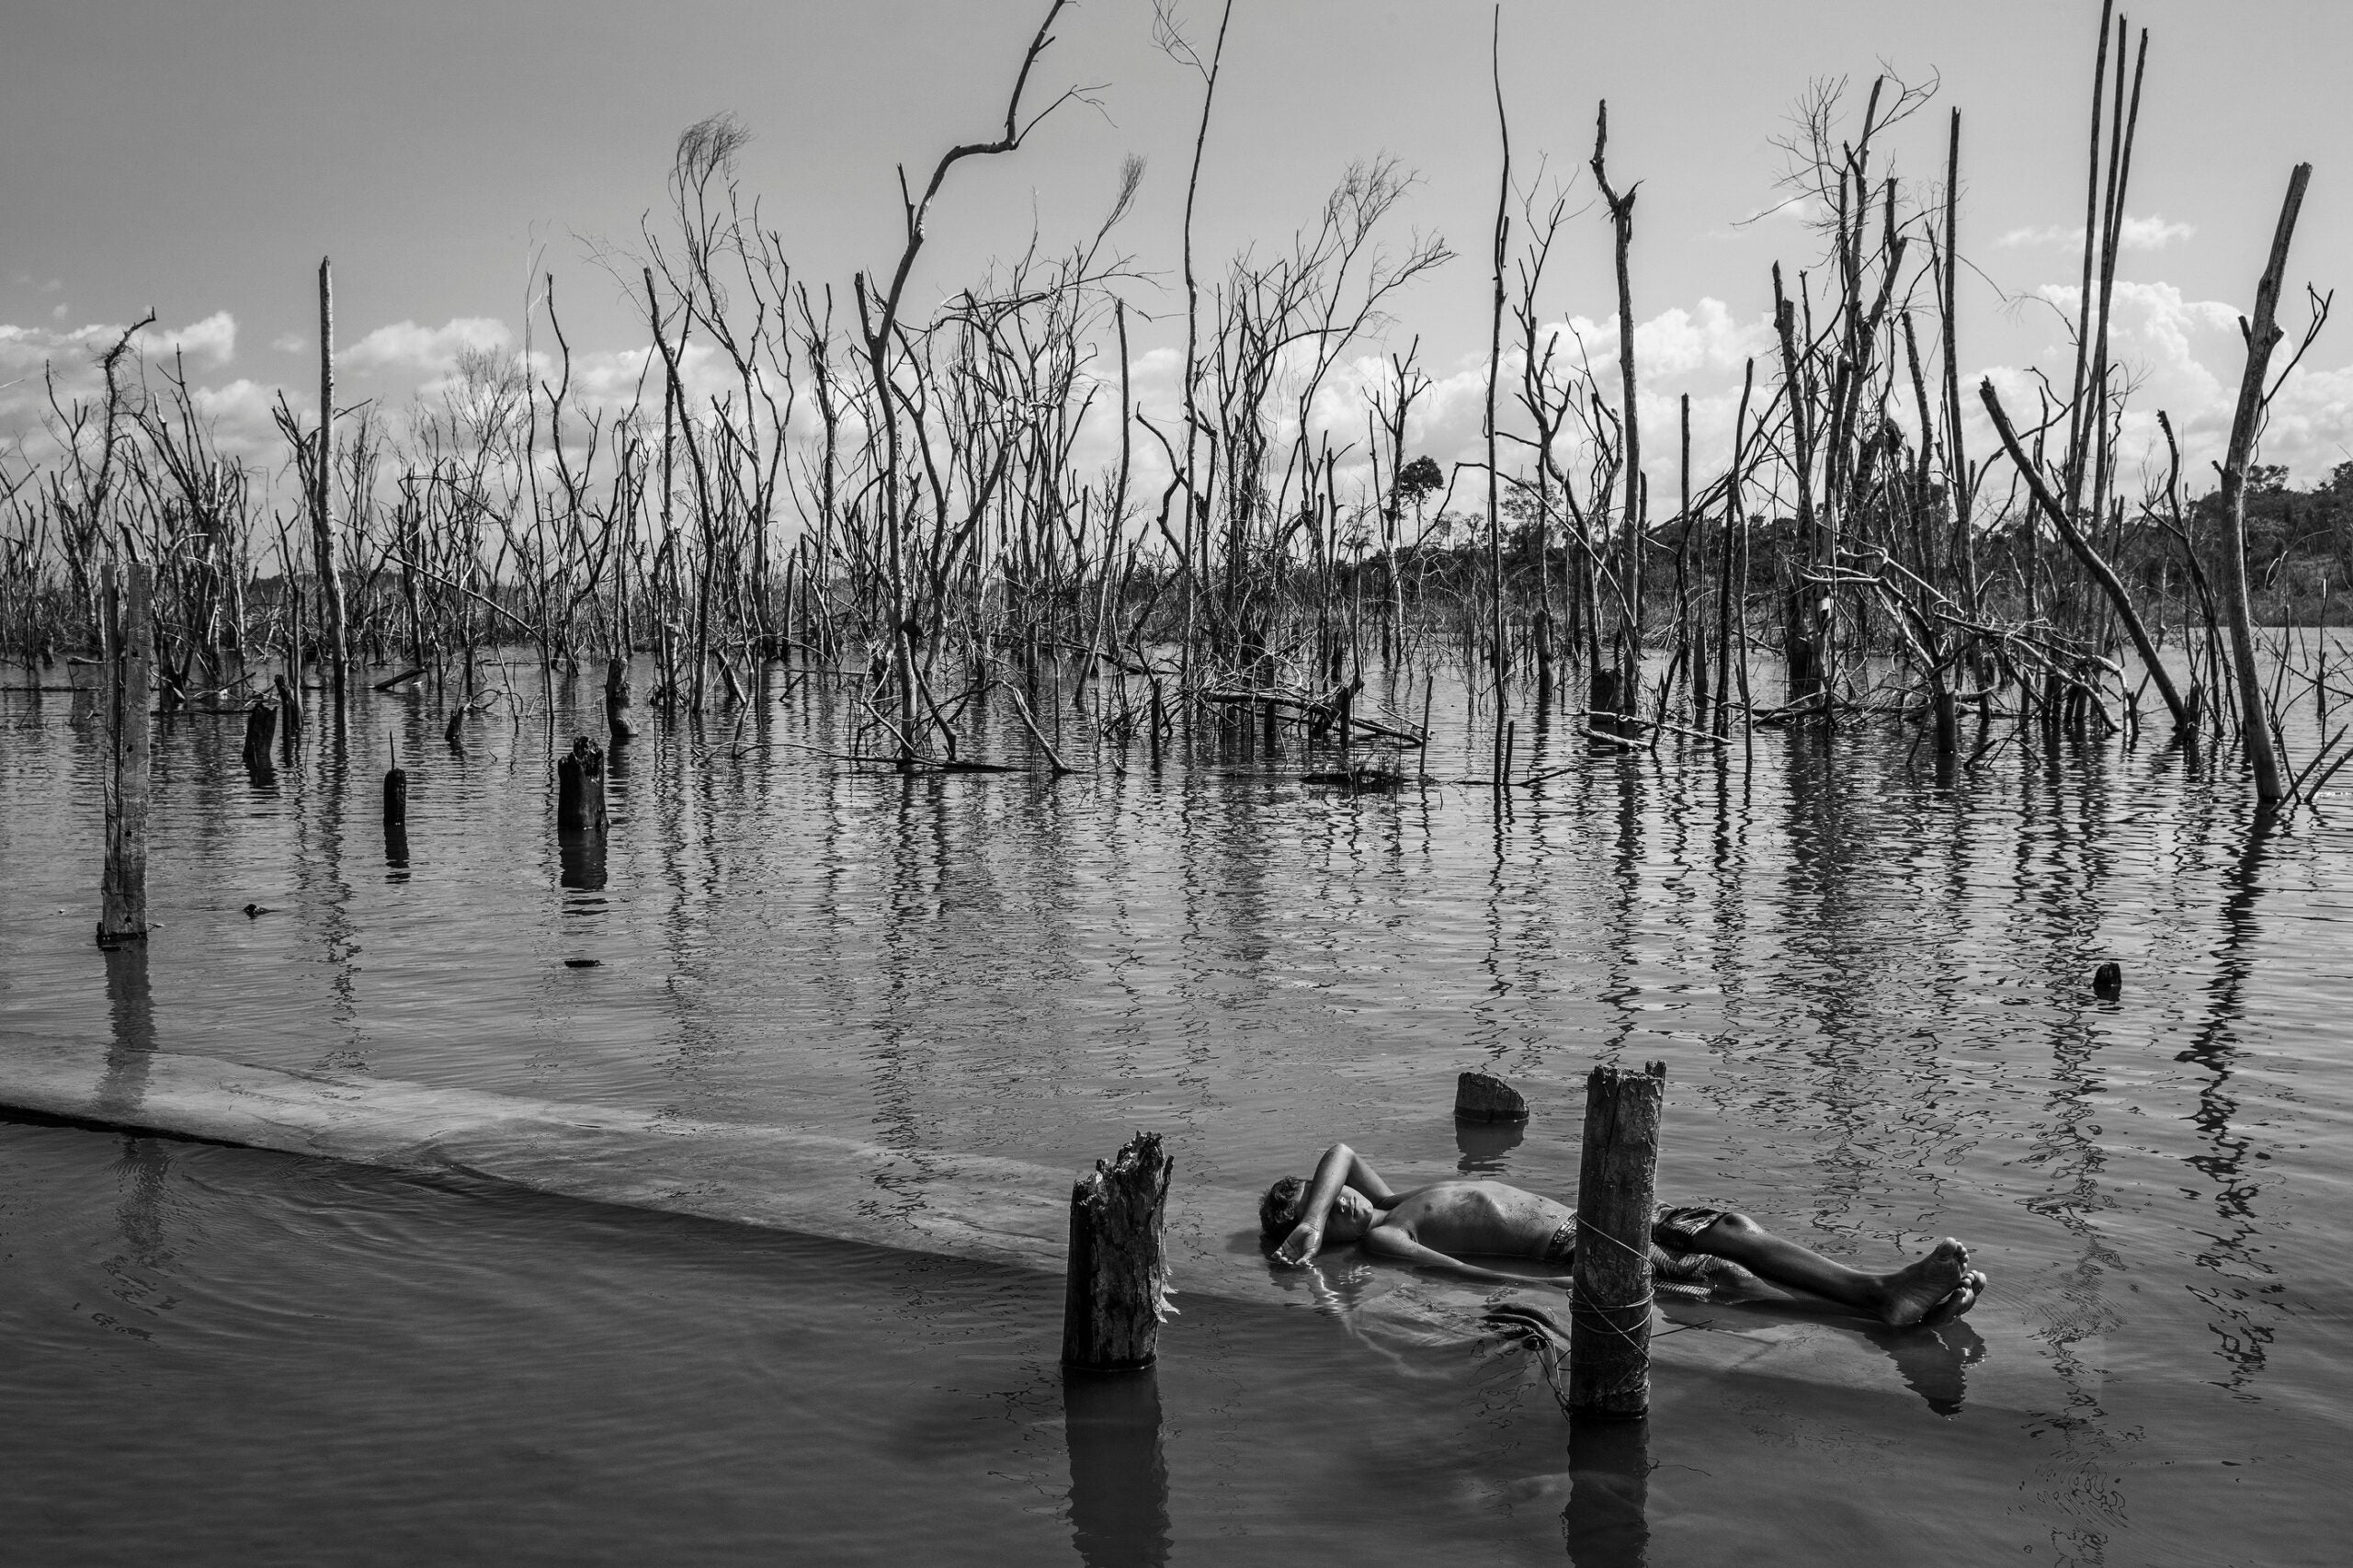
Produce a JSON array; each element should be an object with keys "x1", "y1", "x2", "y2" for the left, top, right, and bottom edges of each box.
[{"x1": 1259, "y1": 1144, "x2": 1986, "y2": 1328}]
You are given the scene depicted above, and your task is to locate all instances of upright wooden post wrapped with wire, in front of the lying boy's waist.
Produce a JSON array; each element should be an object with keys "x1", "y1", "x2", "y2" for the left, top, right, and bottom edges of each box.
[{"x1": 1570, "y1": 1062, "x2": 1665, "y2": 1417}]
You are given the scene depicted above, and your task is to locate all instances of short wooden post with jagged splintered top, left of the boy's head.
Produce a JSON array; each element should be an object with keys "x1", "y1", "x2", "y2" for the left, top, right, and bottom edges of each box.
[{"x1": 1062, "y1": 1132, "x2": 1176, "y2": 1372}]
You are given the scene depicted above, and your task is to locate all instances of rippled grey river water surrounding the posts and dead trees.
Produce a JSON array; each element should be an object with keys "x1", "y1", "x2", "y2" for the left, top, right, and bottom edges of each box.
[{"x1": 0, "y1": 649, "x2": 2353, "y2": 1565}]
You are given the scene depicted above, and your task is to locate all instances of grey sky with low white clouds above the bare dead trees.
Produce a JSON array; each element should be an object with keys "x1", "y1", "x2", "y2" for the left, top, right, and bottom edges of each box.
[{"x1": 0, "y1": 0, "x2": 2353, "y2": 501}]
